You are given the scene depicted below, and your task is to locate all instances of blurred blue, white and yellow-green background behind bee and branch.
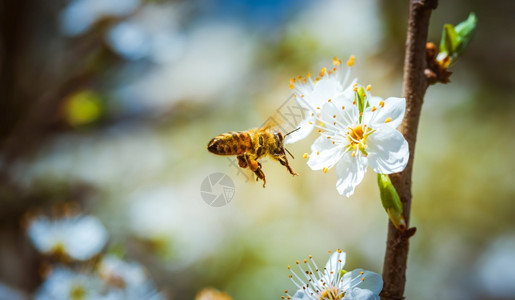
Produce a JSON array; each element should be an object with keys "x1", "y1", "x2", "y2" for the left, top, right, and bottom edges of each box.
[{"x1": 0, "y1": 0, "x2": 515, "y2": 300}]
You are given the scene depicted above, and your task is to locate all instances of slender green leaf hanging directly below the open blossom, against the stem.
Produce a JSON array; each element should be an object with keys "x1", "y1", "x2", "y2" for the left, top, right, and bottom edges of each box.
[{"x1": 377, "y1": 173, "x2": 406, "y2": 231}]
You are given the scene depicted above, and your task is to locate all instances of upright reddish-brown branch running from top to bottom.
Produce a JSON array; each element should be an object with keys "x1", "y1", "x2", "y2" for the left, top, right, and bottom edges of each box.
[{"x1": 381, "y1": 0, "x2": 438, "y2": 300}]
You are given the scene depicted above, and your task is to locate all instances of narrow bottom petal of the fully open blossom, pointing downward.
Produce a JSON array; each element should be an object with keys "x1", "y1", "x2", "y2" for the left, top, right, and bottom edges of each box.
[{"x1": 336, "y1": 152, "x2": 367, "y2": 197}]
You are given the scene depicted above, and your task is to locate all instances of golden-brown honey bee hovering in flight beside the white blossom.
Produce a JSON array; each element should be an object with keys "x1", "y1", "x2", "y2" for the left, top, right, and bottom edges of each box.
[{"x1": 207, "y1": 127, "x2": 298, "y2": 187}]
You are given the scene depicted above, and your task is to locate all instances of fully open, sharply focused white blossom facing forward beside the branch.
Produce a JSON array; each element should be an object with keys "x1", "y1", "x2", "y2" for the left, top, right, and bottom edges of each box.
[{"x1": 304, "y1": 84, "x2": 409, "y2": 197}]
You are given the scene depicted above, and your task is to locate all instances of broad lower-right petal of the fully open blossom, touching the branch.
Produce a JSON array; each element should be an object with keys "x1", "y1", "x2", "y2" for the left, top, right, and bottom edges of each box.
[{"x1": 367, "y1": 125, "x2": 409, "y2": 174}]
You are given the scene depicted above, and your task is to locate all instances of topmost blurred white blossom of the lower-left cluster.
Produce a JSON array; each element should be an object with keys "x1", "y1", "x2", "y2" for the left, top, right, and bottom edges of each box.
[{"x1": 27, "y1": 216, "x2": 108, "y2": 260}]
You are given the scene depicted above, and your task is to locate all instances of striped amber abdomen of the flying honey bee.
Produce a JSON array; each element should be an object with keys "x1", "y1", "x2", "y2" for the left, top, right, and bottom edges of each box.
[{"x1": 207, "y1": 131, "x2": 252, "y2": 155}]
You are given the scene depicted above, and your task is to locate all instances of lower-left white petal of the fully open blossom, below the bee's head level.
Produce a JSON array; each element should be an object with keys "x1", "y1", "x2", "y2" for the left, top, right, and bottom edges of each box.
[{"x1": 308, "y1": 136, "x2": 345, "y2": 170}]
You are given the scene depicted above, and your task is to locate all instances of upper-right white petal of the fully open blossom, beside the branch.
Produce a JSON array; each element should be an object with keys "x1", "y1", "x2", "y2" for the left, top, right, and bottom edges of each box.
[{"x1": 365, "y1": 97, "x2": 406, "y2": 128}]
